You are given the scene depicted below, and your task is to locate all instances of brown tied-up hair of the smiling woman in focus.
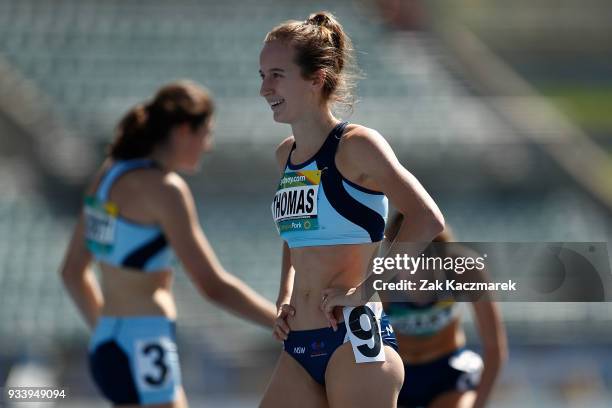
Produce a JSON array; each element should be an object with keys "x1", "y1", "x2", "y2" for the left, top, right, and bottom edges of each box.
[{"x1": 264, "y1": 11, "x2": 360, "y2": 110}]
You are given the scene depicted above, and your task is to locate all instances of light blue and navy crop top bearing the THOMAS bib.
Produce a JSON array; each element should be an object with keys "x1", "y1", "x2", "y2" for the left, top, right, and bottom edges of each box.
[{"x1": 272, "y1": 122, "x2": 389, "y2": 248}]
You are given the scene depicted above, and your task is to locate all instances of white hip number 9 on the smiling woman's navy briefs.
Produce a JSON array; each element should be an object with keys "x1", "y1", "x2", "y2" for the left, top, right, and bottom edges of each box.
[{"x1": 342, "y1": 302, "x2": 385, "y2": 363}]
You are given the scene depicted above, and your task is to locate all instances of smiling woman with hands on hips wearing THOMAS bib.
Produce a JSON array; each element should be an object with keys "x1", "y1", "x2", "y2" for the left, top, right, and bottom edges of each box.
[{"x1": 260, "y1": 12, "x2": 444, "y2": 407}]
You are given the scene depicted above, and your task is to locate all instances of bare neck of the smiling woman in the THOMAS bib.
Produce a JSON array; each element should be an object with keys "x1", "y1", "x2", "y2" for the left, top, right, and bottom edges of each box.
[{"x1": 291, "y1": 109, "x2": 339, "y2": 152}]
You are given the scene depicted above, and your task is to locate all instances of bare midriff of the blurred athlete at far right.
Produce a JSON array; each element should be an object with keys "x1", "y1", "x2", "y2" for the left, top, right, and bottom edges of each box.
[{"x1": 391, "y1": 319, "x2": 465, "y2": 364}]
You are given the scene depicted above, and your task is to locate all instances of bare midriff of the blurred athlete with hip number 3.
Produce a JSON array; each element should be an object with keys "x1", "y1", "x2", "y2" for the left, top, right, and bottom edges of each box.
[{"x1": 100, "y1": 264, "x2": 176, "y2": 320}]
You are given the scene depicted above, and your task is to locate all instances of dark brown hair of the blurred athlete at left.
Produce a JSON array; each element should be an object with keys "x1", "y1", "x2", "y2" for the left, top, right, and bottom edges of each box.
[{"x1": 109, "y1": 80, "x2": 214, "y2": 160}]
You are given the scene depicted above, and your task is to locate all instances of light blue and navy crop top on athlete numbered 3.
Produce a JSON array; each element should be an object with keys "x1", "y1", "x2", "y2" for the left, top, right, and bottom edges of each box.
[{"x1": 84, "y1": 159, "x2": 175, "y2": 272}]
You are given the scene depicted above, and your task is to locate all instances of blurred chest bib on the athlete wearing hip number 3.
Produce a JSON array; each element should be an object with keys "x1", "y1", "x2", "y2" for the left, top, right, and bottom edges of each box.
[{"x1": 84, "y1": 196, "x2": 119, "y2": 253}]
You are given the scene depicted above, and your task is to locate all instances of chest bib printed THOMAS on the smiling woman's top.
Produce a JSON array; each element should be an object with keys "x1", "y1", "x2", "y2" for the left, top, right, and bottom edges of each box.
[{"x1": 271, "y1": 170, "x2": 321, "y2": 233}]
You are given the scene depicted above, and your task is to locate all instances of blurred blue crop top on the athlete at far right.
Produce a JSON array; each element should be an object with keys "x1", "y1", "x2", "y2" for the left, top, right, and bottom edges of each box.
[{"x1": 385, "y1": 299, "x2": 460, "y2": 336}]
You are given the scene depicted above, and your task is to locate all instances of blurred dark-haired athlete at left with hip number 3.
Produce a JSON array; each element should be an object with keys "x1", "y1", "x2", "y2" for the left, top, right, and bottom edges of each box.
[{"x1": 61, "y1": 81, "x2": 276, "y2": 407}]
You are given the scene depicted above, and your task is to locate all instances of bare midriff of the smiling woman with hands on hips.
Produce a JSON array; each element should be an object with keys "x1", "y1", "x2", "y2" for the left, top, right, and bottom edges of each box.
[{"x1": 287, "y1": 243, "x2": 378, "y2": 330}]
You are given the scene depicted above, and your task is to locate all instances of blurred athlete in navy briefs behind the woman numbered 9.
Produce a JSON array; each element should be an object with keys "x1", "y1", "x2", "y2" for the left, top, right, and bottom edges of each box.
[{"x1": 383, "y1": 213, "x2": 508, "y2": 408}]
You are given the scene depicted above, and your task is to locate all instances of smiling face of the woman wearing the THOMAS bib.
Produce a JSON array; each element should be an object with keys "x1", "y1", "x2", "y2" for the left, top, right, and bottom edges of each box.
[{"x1": 259, "y1": 40, "x2": 321, "y2": 123}]
